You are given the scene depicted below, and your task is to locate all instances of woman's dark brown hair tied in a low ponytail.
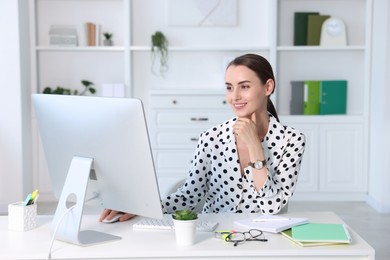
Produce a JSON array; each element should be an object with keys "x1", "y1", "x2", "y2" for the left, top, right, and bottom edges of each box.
[{"x1": 228, "y1": 54, "x2": 279, "y2": 121}]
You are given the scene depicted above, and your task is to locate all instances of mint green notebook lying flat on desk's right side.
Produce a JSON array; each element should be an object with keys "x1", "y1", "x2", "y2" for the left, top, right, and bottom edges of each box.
[{"x1": 291, "y1": 223, "x2": 352, "y2": 244}]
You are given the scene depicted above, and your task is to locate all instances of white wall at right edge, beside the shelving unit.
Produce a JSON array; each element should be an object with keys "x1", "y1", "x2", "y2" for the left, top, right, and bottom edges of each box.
[{"x1": 368, "y1": 0, "x2": 390, "y2": 212}]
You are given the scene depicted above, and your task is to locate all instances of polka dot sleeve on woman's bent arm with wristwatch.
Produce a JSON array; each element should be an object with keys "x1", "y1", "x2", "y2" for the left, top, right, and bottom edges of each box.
[{"x1": 246, "y1": 129, "x2": 305, "y2": 214}]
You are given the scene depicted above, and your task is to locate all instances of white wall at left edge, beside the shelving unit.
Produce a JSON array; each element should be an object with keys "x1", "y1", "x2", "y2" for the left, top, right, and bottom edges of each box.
[{"x1": 0, "y1": 0, "x2": 32, "y2": 211}]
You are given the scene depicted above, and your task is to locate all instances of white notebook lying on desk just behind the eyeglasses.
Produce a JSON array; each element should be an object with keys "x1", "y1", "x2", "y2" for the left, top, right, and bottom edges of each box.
[{"x1": 234, "y1": 215, "x2": 309, "y2": 233}]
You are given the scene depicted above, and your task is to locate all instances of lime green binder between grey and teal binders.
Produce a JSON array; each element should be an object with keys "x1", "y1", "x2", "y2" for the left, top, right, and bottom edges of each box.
[{"x1": 303, "y1": 80, "x2": 321, "y2": 115}]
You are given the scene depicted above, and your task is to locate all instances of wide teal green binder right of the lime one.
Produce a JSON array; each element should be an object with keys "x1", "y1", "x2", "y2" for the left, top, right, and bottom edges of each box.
[{"x1": 320, "y1": 80, "x2": 347, "y2": 115}]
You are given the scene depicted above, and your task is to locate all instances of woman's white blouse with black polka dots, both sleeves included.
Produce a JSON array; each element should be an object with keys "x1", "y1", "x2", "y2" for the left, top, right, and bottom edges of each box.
[{"x1": 162, "y1": 114, "x2": 305, "y2": 214}]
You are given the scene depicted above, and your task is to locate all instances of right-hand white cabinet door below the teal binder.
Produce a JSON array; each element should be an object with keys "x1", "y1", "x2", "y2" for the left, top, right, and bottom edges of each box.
[{"x1": 319, "y1": 123, "x2": 367, "y2": 192}]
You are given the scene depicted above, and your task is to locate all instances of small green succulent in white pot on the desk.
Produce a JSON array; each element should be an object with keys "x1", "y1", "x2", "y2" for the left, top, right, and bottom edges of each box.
[{"x1": 172, "y1": 209, "x2": 198, "y2": 246}]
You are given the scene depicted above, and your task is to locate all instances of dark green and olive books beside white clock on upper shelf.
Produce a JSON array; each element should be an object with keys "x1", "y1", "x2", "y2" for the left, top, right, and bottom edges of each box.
[{"x1": 294, "y1": 12, "x2": 330, "y2": 46}]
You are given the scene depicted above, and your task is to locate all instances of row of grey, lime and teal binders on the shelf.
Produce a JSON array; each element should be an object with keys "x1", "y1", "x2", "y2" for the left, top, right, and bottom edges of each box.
[{"x1": 290, "y1": 80, "x2": 347, "y2": 115}]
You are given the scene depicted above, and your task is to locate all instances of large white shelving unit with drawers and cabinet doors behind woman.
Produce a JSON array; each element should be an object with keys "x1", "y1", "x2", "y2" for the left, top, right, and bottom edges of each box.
[{"x1": 30, "y1": 0, "x2": 372, "y2": 200}]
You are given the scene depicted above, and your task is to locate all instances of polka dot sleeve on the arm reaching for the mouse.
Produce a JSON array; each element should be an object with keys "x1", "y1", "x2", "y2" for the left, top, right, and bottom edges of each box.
[{"x1": 161, "y1": 133, "x2": 211, "y2": 214}]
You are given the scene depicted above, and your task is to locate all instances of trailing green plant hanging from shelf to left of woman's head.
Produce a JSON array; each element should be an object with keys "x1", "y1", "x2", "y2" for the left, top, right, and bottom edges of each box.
[{"x1": 152, "y1": 31, "x2": 168, "y2": 75}]
